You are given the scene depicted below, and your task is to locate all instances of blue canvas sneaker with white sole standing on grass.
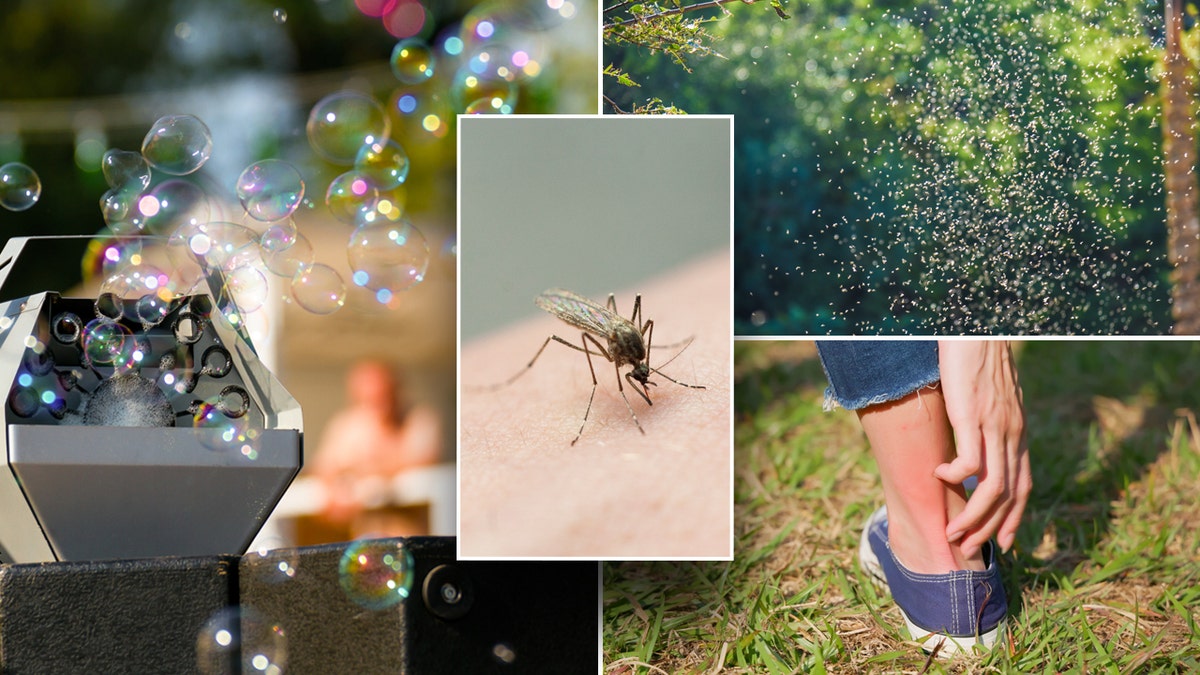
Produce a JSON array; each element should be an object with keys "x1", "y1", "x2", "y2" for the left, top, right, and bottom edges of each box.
[{"x1": 858, "y1": 507, "x2": 1008, "y2": 657}]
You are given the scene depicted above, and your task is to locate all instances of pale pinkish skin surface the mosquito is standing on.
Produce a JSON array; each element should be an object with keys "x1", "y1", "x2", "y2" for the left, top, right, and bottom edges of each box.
[{"x1": 458, "y1": 252, "x2": 732, "y2": 558}]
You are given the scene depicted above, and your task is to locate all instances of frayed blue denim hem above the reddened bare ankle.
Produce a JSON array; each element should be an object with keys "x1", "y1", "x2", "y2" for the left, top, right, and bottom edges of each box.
[{"x1": 817, "y1": 340, "x2": 941, "y2": 410}]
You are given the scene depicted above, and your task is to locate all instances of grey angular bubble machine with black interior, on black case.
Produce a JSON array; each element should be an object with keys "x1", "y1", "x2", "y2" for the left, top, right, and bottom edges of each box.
[{"x1": 0, "y1": 238, "x2": 302, "y2": 562}]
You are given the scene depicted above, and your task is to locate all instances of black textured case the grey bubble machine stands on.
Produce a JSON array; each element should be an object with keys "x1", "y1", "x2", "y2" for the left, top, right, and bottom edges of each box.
[{"x1": 0, "y1": 537, "x2": 600, "y2": 674}]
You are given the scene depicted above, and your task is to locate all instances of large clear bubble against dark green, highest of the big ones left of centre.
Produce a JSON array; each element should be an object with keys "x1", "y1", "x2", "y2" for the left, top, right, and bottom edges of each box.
[{"x1": 306, "y1": 91, "x2": 391, "y2": 165}]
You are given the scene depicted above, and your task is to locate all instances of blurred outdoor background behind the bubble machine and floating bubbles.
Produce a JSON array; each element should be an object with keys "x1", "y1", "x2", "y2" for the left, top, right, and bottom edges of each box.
[{"x1": 0, "y1": 0, "x2": 599, "y2": 544}]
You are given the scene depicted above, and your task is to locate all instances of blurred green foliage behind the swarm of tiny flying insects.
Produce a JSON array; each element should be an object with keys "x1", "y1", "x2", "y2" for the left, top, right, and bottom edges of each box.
[{"x1": 606, "y1": 0, "x2": 1169, "y2": 334}]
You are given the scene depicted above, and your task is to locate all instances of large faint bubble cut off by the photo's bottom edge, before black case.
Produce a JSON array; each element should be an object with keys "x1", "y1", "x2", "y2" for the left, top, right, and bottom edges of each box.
[{"x1": 196, "y1": 605, "x2": 288, "y2": 675}]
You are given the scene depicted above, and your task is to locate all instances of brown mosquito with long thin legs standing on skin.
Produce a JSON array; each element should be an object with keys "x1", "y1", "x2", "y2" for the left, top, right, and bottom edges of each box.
[{"x1": 496, "y1": 288, "x2": 704, "y2": 446}]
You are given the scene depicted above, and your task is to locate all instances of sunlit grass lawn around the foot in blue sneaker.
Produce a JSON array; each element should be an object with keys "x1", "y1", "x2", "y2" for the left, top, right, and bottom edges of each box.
[{"x1": 604, "y1": 341, "x2": 1200, "y2": 674}]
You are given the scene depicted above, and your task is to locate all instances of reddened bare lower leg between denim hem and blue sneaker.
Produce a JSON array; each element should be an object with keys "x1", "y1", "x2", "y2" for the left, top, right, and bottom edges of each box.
[{"x1": 857, "y1": 387, "x2": 984, "y2": 574}]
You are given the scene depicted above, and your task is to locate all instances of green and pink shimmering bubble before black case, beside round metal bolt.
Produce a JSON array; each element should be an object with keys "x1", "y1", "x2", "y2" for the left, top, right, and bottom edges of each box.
[{"x1": 337, "y1": 539, "x2": 414, "y2": 610}]
